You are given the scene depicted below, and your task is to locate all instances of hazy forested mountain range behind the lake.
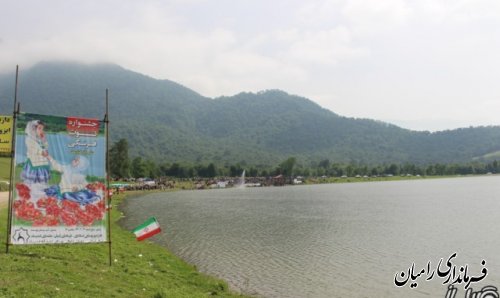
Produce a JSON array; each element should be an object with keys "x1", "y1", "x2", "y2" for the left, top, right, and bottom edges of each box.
[{"x1": 0, "y1": 62, "x2": 500, "y2": 165}]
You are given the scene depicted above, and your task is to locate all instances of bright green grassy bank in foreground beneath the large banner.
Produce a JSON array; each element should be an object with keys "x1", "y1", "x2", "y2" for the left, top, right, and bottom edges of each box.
[{"x1": 0, "y1": 190, "x2": 248, "y2": 297}]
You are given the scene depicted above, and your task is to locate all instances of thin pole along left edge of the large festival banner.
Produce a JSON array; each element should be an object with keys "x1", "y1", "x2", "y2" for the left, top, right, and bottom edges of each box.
[{"x1": 5, "y1": 65, "x2": 20, "y2": 254}]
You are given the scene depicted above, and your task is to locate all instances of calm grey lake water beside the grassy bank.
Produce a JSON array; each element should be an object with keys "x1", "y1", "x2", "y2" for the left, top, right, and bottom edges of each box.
[{"x1": 123, "y1": 176, "x2": 500, "y2": 298}]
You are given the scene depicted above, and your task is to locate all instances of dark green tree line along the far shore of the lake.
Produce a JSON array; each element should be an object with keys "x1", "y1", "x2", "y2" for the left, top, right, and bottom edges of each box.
[{"x1": 110, "y1": 139, "x2": 500, "y2": 178}]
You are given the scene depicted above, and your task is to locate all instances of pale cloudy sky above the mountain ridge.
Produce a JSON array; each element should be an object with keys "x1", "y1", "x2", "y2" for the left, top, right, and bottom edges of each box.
[{"x1": 0, "y1": 0, "x2": 500, "y2": 131}]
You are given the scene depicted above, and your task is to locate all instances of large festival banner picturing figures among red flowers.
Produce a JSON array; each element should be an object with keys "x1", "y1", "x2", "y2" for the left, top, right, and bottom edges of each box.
[{"x1": 11, "y1": 113, "x2": 107, "y2": 244}]
